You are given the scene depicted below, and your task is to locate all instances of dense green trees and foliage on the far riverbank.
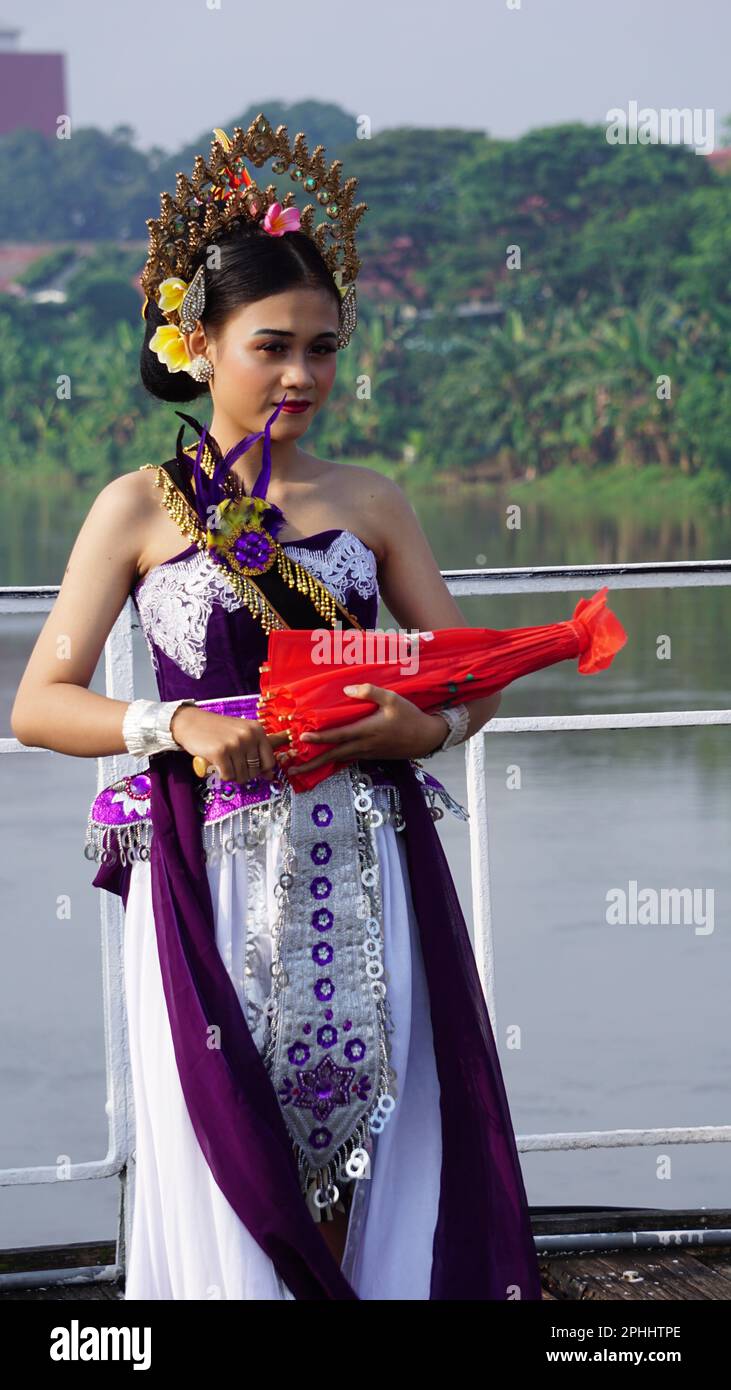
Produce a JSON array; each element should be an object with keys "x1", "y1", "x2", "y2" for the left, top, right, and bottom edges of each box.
[{"x1": 0, "y1": 103, "x2": 731, "y2": 484}]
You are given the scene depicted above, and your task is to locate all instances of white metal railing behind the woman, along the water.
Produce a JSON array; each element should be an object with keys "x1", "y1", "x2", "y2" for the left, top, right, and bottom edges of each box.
[{"x1": 0, "y1": 560, "x2": 731, "y2": 1287}]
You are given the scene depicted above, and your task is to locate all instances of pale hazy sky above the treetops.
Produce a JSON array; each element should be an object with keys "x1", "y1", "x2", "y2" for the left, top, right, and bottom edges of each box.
[{"x1": 0, "y1": 0, "x2": 731, "y2": 150}]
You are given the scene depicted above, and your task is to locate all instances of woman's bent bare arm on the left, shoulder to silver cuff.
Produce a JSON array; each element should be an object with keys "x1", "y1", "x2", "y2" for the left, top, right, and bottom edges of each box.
[{"x1": 10, "y1": 473, "x2": 158, "y2": 758}]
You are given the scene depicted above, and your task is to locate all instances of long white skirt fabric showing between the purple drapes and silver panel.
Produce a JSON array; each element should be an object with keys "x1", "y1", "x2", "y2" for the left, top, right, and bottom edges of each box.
[{"x1": 125, "y1": 821, "x2": 442, "y2": 1300}]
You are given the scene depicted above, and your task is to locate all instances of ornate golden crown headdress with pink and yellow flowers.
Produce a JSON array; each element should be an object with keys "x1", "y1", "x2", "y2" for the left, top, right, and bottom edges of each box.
[{"x1": 142, "y1": 111, "x2": 368, "y2": 379}]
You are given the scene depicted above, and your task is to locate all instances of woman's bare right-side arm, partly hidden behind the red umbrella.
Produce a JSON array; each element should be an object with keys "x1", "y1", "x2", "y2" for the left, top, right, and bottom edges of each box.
[{"x1": 379, "y1": 478, "x2": 500, "y2": 748}]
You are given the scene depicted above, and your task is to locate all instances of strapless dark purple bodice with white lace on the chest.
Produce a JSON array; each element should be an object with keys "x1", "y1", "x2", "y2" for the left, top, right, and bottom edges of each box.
[{"x1": 132, "y1": 527, "x2": 379, "y2": 701}]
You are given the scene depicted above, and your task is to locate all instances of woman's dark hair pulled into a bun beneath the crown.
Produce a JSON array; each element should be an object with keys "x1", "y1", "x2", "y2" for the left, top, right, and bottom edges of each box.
[{"x1": 139, "y1": 222, "x2": 340, "y2": 400}]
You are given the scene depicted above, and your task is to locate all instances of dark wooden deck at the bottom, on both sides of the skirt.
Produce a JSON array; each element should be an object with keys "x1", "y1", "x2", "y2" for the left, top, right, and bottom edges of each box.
[{"x1": 0, "y1": 1208, "x2": 731, "y2": 1302}]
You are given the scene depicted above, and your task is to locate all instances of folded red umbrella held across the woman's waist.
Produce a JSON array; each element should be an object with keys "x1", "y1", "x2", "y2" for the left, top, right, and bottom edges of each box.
[{"x1": 258, "y1": 587, "x2": 627, "y2": 791}]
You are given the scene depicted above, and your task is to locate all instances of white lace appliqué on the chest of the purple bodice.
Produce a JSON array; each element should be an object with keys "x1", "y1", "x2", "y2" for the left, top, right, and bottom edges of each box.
[{"x1": 136, "y1": 531, "x2": 378, "y2": 680}]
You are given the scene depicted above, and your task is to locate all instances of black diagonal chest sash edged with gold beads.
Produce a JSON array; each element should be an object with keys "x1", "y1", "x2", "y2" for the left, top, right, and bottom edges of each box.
[{"x1": 140, "y1": 449, "x2": 363, "y2": 635}]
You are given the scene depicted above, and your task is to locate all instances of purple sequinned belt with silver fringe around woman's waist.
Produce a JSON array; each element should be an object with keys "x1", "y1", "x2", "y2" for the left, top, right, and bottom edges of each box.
[{"x1": 83, "y1": 694, "x2": 467, "y2": 865}]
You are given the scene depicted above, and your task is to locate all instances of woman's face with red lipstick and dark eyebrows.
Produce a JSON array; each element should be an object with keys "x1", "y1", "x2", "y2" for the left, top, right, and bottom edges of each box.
[{"x1": 189, "y1": 289, "x2": 338, "y2": 441}]
